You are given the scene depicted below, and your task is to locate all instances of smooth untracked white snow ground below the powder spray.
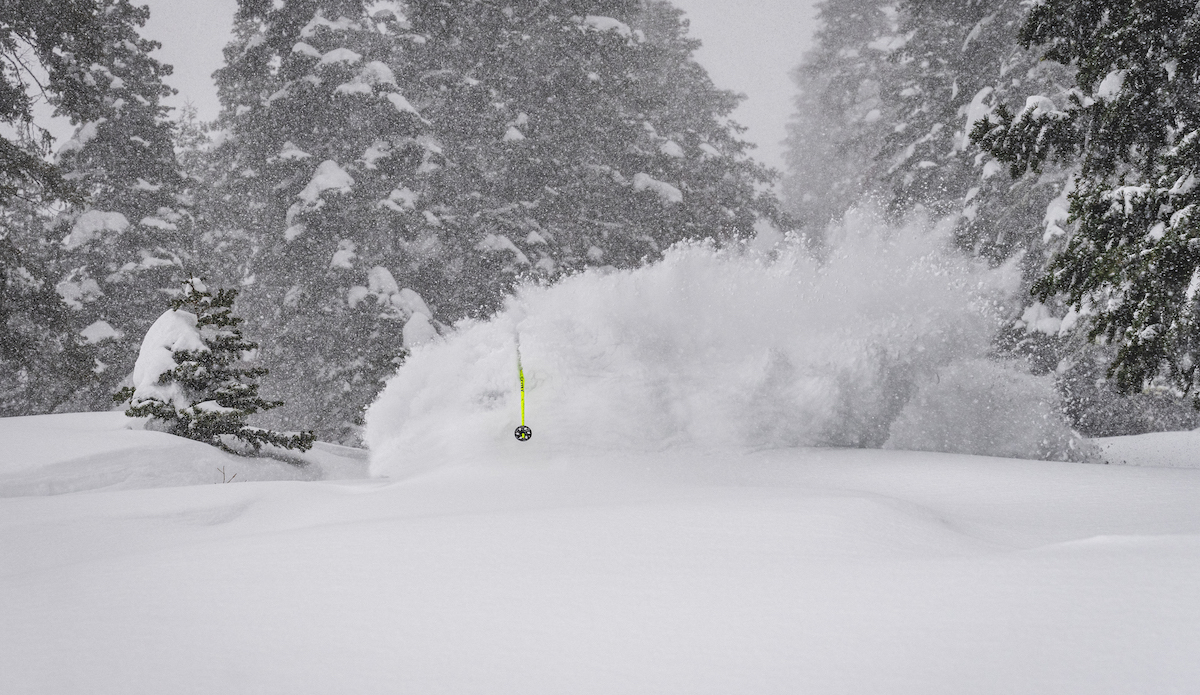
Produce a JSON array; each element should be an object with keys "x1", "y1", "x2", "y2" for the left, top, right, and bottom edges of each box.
[{"x1": 0, "y1": 413, "x2": 1200, "y2": 695}]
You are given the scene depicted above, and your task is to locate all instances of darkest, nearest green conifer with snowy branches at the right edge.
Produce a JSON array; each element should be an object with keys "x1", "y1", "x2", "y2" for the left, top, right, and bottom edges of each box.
[{"x1": 972, "y1": 0, "x2": 1200, "y2": 405}]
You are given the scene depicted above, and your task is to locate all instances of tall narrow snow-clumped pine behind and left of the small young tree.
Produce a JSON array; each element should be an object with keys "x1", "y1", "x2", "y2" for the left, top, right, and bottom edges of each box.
[{"x1": 49, "y1": 0, "x2": 192, "y2": 409}]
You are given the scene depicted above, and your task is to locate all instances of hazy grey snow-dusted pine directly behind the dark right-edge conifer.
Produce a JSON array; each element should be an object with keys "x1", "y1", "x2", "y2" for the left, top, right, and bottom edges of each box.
[{"x1": 881, "y1": 0, "x2": 1069, "y2": 272}]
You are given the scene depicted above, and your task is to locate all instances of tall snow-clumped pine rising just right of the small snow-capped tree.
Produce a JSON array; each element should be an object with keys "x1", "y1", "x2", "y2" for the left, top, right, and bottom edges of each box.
[{"x1": 203, "y1": 0, "x2": 443, "y2": 441}]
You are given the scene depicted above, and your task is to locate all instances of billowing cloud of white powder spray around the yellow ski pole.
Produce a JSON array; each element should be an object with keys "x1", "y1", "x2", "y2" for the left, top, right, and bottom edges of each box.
[{"x1": 366, "y1": 207, "x2": 1089, "y2": 475}]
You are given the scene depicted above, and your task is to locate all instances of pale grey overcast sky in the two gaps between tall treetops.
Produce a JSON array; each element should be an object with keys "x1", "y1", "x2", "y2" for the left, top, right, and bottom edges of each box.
[{"x1": 143, "y1": 0, "x2": 816, "y2": 168}]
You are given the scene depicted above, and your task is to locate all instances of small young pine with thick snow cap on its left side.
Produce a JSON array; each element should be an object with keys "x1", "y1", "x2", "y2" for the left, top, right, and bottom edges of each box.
[{"x1": 113, "y1": 277, "x2": 313, "y2": 454}]
